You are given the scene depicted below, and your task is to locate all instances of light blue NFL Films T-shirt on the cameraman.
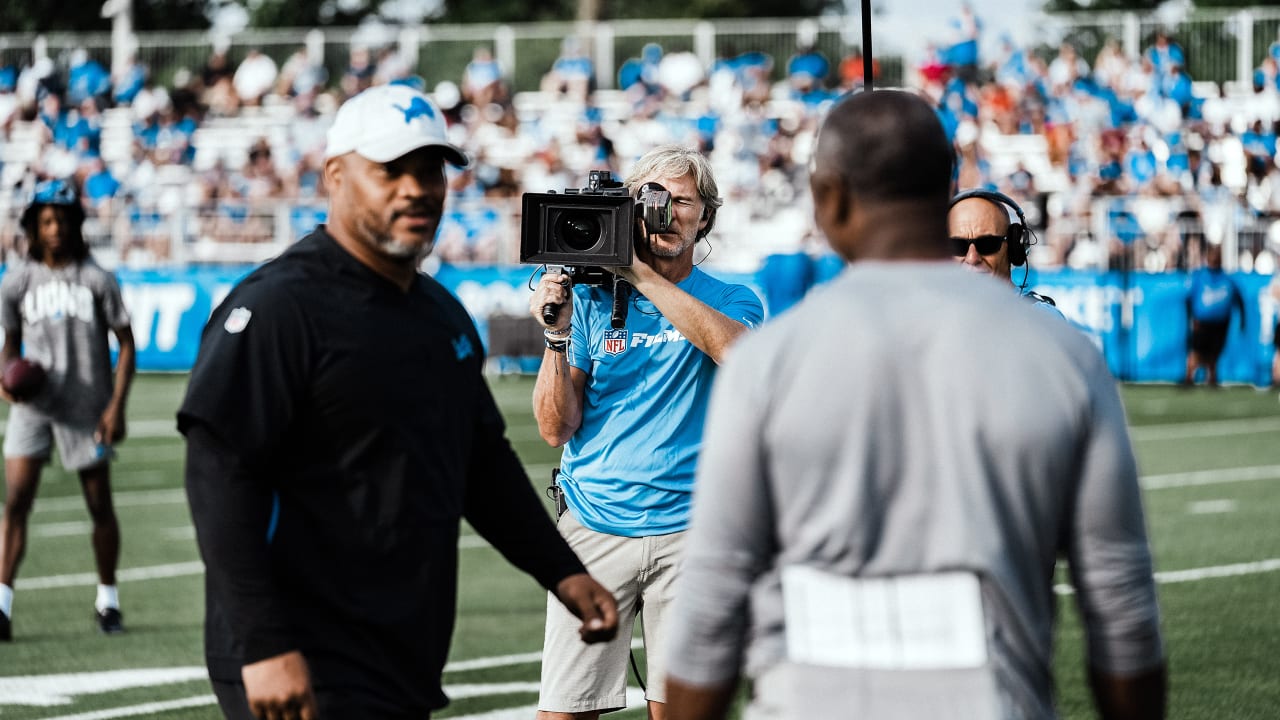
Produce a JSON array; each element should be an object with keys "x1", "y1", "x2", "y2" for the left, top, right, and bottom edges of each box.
[{"x1": 559, "y1": 268, "x2": 764, "y2": 537}]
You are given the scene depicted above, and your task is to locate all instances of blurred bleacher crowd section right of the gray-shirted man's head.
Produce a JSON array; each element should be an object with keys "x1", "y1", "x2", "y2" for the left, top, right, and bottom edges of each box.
[{"x1": 919, "y1": 9, "x2": 1280, "y2": 272}]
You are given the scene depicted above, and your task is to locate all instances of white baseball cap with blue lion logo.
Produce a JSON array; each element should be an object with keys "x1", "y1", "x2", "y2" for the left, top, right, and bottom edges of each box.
[{"x1": 324, "y1": 83, "x2": 471, "y2": 168}]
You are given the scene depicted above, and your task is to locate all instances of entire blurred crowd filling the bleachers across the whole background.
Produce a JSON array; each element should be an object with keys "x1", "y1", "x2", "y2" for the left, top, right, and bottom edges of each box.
[{"x1": 0, "y1": 6, "x2": 1280, "y2": 272}]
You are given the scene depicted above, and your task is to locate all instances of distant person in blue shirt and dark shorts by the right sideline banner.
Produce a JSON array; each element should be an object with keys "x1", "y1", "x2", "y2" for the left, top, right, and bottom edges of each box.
[{"x1": 1181, "y1": 245, "x2": 1245, "y2": 387}]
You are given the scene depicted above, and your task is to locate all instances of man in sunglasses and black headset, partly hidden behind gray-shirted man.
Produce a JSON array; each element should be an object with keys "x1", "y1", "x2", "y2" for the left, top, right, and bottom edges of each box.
[{"x1": 947, "y1": 190, "x2": 1062, "y2": 315}]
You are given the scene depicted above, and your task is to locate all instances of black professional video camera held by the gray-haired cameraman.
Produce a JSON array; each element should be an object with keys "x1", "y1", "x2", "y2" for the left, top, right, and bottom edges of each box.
[{"x1": 520, "y1": 170, "x2": 672, "y2": 328}]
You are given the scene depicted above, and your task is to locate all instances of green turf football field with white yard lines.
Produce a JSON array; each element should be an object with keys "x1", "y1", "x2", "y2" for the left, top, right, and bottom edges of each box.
[{"x1": 0, "y1": 375, "x2": 1280, "y2": 720}]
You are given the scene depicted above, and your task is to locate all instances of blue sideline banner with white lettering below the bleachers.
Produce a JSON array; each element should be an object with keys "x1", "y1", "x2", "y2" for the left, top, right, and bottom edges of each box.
[{"x1": 5, "y1": 255, "x2": 1280, "y2": 386}]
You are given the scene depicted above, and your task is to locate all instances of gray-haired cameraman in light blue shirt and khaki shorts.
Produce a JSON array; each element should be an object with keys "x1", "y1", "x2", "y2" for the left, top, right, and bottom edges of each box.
[{"x1": 530, "y1": 145, "x2": 764, "y2": 720}]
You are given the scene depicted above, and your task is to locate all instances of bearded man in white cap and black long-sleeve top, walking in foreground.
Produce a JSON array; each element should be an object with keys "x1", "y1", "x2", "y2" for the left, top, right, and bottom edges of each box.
[{"x1": 178, "y1": 85, "x2": 617, "y2": 719}]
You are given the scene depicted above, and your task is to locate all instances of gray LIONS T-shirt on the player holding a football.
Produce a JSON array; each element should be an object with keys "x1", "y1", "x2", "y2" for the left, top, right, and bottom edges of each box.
[{"x1": 0, "y1": 259, "x2": 129, "y2": 424}]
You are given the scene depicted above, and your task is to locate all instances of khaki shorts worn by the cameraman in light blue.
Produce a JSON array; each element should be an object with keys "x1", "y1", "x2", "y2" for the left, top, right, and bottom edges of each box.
[{"x1": 538, "y1": 511, "x2": 685, "y2": 712}]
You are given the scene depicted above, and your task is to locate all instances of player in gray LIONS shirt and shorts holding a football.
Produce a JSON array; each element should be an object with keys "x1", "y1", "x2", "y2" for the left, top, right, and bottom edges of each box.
[{"x1": 0, "y1": 179, "x2": 136, "y2": 641}]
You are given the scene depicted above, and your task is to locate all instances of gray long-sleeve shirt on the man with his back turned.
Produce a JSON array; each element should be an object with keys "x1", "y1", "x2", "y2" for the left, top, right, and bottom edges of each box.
[{"x1": 668, "y1": 263, "x2": 1164, "y2": 719}]
